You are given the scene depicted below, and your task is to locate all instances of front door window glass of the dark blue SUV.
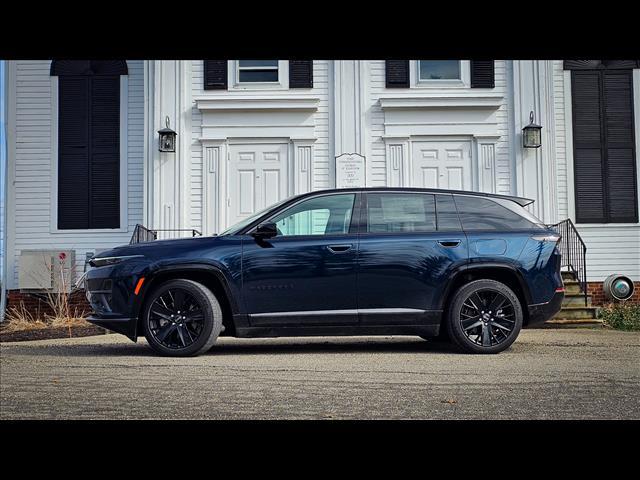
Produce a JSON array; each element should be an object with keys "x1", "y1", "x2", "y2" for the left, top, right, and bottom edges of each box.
[{"x1": 271, "y1": 194, "x2": 355, "y2": 237}]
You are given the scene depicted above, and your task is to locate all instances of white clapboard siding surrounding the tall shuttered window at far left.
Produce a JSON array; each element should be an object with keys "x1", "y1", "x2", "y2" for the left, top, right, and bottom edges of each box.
[{"x1": 8, "y1": 60, "x2": 144, "y2": 288}]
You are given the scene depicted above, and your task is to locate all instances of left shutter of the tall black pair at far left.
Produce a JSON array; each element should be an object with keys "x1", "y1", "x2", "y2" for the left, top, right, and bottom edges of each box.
[{"x1": 58, "y1": 77, "x2": 90, "y2": 230}]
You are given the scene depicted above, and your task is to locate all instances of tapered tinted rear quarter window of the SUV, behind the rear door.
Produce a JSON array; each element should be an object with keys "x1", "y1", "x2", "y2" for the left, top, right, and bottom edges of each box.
[{"x1": 454, "y1": 195, "x2": 535, "y2": 230}]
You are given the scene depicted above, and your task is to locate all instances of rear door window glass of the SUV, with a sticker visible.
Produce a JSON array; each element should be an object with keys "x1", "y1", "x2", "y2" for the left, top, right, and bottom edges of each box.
[{"x1": 368, "y1": 193, "x2": 436, "y2": 233}]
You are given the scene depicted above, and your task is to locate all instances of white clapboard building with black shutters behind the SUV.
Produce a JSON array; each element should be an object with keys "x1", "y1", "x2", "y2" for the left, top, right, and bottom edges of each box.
[{"x1": 4, "y1": 60, "x2": 640, "y2": 312}]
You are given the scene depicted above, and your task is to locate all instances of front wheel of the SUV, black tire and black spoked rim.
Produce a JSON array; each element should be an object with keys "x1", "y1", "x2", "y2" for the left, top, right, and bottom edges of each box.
[{"x1": 142, "y1": 279, "x2": 222, "y2": 357}]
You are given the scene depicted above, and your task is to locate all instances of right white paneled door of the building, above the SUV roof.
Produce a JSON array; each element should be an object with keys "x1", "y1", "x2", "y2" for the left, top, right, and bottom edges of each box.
[{"x1": 410, "y1": 141, "x2": 473, "y2": 190}]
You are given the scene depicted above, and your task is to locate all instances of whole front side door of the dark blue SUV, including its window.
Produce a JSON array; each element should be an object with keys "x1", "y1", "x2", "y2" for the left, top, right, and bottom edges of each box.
[{"x1": 242, "y1": 193, "x2": 359, "y2": 326}]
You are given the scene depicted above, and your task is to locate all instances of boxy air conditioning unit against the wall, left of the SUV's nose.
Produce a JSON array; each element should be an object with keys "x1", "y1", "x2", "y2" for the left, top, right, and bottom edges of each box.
[{"x1": 18, "y1": 250, "x2": 76, "y2": 293}]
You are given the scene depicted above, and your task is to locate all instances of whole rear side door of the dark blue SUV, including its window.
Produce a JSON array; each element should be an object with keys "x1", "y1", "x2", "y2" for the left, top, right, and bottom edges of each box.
[{"x1": 358, "y1": 192, "x2": 468, "y2": 325}]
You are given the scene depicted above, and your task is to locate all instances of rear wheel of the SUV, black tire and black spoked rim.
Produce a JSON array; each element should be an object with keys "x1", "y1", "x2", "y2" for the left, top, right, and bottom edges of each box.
[{"x1": 447, "y1": 280, "x2": 523, "y2": 353}]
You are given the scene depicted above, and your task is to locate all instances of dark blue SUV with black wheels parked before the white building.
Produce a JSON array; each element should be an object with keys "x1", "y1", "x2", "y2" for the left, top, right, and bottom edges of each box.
[{"x1": 86, "y1": 188, "x2": 564, "y2": 356}]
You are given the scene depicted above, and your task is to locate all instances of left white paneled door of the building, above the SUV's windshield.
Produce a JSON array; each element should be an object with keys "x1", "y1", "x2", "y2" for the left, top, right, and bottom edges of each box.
[{"x1": 227, "y1": 143, "x2": 289, "y2": 226}]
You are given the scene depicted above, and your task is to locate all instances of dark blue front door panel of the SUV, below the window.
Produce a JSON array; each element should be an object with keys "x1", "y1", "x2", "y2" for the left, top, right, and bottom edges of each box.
[{"x1": 242, "y1": 234, "x2": 358, "y2": 326}]
